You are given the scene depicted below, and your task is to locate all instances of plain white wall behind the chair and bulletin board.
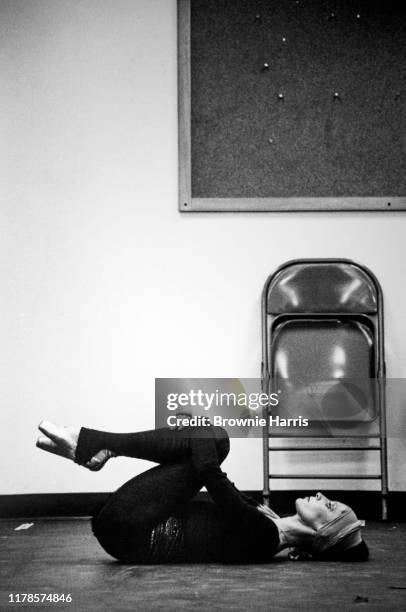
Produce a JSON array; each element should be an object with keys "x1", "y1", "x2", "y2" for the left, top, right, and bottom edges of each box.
[{"x1": 0, "y1": 0, "x2": 406, "y2": 494}]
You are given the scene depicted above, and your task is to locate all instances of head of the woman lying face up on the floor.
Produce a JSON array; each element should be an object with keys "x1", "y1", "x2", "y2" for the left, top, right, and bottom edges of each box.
[{"x1": 295, "y1": 493, "x2": 369, "y2": 561}]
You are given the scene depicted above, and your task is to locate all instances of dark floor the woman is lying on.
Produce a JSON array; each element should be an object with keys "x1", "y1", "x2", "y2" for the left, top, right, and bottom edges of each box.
[{"x1": 0, "y1": 519, "x2": 406, "y2": 612}]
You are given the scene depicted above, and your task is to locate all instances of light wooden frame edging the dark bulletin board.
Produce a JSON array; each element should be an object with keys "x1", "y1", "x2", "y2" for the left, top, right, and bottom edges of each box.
[{"x1": 177, "y1": 0, "x2": 406, "y2": 212}]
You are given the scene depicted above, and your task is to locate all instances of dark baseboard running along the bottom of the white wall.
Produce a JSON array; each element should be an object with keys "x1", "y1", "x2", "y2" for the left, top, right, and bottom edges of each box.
[{"x1": 0, "y1": 491, "x2": 406, "y2": 522}]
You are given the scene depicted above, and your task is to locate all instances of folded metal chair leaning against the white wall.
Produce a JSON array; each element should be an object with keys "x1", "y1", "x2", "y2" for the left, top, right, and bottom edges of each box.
[{"x1": 262, "y1": 259, "x2": 388, "y2": 520}]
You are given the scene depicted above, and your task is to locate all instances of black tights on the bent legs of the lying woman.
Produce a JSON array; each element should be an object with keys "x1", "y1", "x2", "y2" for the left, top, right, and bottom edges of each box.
[{"x1": 76, "y1": 427, "x2": 230, "y2": 562}]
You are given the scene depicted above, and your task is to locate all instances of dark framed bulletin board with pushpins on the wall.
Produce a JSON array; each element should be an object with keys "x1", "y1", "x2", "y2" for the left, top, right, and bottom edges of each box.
[{"x1": 178, "y1": 0, "x2": 406, "y2": 212}]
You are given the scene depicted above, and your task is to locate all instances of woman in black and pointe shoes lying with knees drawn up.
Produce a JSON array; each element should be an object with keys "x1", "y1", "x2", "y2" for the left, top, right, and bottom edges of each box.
[{"x1": 37, "y1": 421, "x2": 368, "y2": 564}]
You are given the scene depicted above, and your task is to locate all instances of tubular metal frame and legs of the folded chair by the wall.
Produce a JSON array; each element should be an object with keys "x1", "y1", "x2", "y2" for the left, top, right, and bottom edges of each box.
[{"x1": 261, "y1": 258, "x2": 388, "y2": 520}]
